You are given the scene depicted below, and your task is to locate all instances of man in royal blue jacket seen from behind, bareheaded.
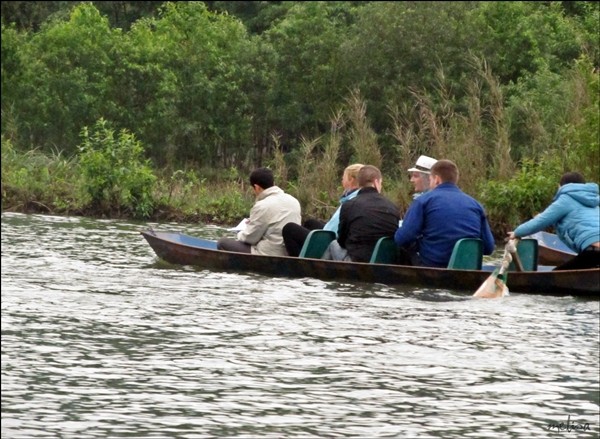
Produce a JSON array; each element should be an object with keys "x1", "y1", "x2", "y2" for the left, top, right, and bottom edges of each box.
[{"x1": 394, "y1": 160, "x2": 495, "y2": 267}]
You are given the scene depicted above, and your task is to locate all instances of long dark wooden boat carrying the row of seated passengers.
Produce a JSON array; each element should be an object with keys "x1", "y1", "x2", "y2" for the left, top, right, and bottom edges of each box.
[{"x1": 141, "y1": 230, "x2": 600, "y2": 298}]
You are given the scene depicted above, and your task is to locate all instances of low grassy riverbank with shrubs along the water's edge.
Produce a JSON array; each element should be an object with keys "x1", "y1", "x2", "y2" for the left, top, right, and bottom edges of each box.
[{"x1": 1, "y1": 136, "x2": 559, "y2": 240}]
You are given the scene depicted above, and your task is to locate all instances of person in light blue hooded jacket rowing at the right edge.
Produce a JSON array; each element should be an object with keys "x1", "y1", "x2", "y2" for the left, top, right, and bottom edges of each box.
[{"x1": 508, "y1": 172, "x2": 600, "y2": 270}]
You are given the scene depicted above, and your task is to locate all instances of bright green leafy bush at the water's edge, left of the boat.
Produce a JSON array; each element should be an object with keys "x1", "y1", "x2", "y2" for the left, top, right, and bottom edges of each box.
[{"x1": 79, "y1": 119, "x2": 156, "y2": 218}]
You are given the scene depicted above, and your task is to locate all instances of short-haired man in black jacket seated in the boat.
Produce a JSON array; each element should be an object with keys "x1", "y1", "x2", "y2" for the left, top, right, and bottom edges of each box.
[{"x1": 323, "y1": 165, "x2": 400, "y2": 262}]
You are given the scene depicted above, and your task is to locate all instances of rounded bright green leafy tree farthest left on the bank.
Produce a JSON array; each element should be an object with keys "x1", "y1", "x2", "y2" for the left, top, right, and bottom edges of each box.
[{"x1": 7, "y1": 4, "x2": 118, "y2": 153}]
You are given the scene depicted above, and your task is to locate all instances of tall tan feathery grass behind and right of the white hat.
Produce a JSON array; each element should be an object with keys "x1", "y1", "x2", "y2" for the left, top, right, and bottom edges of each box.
[{"x1": 389, "y1": 58, "x2": 514, "y2": 201}]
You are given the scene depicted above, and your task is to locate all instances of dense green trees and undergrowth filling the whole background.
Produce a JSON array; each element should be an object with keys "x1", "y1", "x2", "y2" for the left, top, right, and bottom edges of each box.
[{"x1": 1, "y1": 1, "x2": 600, "y2": 232}]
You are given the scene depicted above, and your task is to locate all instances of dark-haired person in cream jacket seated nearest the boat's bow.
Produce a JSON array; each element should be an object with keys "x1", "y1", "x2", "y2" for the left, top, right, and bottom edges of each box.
[{"x1": 217, "y1": 168, "x2": 301, "y2": 256}]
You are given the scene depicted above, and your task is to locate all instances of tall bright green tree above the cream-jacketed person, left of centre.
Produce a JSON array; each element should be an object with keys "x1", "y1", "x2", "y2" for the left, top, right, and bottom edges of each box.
[{"x1": 134, "y1": 2, "x2": 252, "y2": 164}]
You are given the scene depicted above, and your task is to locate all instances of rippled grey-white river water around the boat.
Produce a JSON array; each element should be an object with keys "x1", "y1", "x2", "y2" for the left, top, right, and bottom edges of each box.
[{"x1": 2, "y1": 213, "x2": 600, "y2": 439}]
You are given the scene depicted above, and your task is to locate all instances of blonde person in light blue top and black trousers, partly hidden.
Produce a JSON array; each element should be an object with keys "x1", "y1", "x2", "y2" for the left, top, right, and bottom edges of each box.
[{"x1": 282, "y1": 163, "x2": 363, "y2": 256}]
